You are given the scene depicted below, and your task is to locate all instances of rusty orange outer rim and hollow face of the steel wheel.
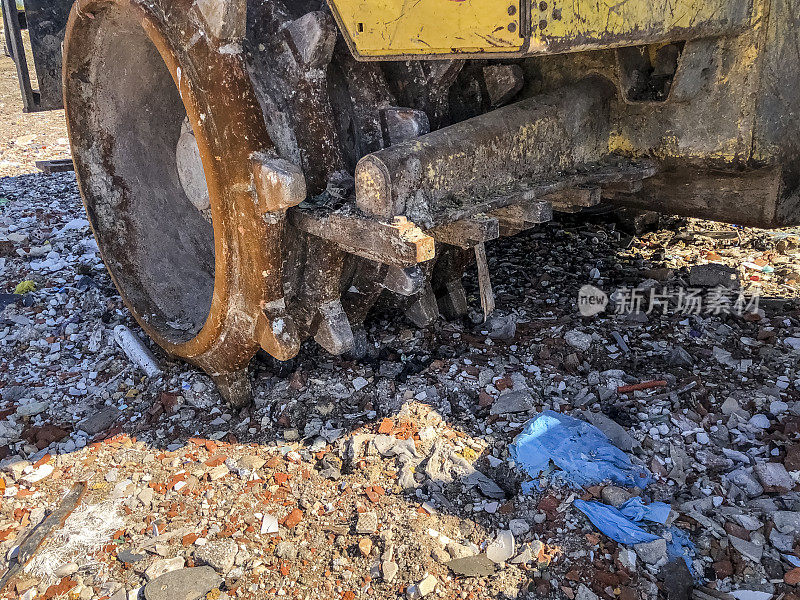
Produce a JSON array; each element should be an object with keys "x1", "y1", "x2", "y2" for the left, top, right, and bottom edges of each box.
[{"x1": 64, "y1": 0, "x2": 304, "y2": 405}]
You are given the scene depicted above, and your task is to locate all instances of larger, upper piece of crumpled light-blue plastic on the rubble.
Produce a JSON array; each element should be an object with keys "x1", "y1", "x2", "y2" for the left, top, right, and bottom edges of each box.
[{"x1": 509, "y1": 410, "x2": 651, "y2": 493}]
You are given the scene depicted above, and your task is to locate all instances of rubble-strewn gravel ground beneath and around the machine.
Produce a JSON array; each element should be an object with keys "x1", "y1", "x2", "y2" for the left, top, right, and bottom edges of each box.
[{"x1": 0, "y1": 21, "x2": 800, "y2": 600}]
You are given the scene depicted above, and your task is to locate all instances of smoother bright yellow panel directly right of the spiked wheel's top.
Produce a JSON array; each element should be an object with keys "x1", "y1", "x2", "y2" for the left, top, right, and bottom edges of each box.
[{"x1": 329, "y1": 0, "x2": 523, "y2": 57}]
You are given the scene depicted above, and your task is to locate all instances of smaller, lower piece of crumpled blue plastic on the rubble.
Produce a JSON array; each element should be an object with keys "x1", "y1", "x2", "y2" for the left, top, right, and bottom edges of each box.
[{"x1": 573, "y1": 498, "x2": 670, "y2": 545}]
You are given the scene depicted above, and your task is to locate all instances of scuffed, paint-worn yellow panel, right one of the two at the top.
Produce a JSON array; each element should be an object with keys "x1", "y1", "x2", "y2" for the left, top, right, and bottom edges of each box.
[{"x1": 530, "y1": 0, "x2": 752, "y2": 53}]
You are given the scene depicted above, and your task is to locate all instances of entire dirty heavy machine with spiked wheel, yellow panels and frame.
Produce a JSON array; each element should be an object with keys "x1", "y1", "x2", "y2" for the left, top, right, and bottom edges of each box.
[{"x1": 5, "y1": 0, "x2": 800, "y2": 405}]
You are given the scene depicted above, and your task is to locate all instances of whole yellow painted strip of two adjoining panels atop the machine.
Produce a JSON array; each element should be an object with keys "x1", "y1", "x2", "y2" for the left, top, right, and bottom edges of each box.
[{"x1": 329, "y1": 0, "x2": 754, "y2": 59}]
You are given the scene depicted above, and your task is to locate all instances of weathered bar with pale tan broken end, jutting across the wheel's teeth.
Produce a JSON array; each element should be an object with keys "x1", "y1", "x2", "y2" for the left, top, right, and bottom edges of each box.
[{"x1": 289, "y1": 208, "x2": 436, "y2": 267}]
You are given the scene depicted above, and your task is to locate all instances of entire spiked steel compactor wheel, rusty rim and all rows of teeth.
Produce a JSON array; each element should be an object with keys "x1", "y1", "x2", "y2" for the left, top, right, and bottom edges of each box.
[{"x1": 64, "y1": 0, "x2": 494, "y2": 406}]
